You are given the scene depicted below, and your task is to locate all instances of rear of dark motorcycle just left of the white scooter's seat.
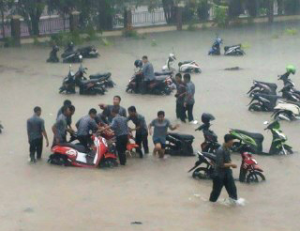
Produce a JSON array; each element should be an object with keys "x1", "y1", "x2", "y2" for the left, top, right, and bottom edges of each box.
[{"x1": 248, "y1": 94, "x2": 280, "y2": 112}]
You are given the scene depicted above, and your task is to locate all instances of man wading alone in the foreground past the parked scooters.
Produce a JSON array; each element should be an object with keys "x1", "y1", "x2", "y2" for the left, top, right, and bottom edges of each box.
[{"x1": 209, "y1": 134, "x2": 237, "y2": 202}]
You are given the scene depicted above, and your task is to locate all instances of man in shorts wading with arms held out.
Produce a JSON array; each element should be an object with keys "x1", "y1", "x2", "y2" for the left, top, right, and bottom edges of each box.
[{"x1": 148, "y1": 111, "x2": 179, "y2": 158}]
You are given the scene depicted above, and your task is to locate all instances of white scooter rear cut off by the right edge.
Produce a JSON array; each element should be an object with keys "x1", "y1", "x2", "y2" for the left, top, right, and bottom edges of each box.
[{"x1": 272, "y1": 102, "x2": 300, "y2": 121}]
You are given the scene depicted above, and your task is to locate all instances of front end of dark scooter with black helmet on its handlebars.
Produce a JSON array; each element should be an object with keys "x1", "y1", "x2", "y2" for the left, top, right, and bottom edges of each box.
[{"x1": 196, "y1": 113, "x2": 220, "y2": 153}]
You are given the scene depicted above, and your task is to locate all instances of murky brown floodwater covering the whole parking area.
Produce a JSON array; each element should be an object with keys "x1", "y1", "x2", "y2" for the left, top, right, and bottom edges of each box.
[{"x1": 0, "y1": 20, "x2": 300, "y2": 231}]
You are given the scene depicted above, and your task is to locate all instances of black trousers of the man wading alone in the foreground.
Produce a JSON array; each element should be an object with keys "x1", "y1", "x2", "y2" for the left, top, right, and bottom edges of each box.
[{"x1": 209, "y1": 173, "x2": 237, "y2": 202}]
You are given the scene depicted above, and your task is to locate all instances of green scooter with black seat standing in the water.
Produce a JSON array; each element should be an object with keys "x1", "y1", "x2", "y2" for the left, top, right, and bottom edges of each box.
[{"x1": 230, "y1": 120, "x2": 293, "y2": 155}]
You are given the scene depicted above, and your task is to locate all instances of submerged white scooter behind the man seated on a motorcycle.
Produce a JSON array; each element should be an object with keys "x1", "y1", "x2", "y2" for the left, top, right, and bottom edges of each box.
[{"x1": 162, "y1": 53, "x2": 201, "y2": 73}]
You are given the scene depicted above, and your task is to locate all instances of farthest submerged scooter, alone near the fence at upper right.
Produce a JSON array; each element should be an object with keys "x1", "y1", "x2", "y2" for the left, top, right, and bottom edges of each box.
[{"x1": 208, "y1": 38, "x2": 245, "y2": 56}]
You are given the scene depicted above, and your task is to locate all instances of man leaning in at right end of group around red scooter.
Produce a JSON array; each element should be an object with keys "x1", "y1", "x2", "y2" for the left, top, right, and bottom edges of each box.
[{"x1": 128, "y1": 106, "x2": 149, "y2": 158}]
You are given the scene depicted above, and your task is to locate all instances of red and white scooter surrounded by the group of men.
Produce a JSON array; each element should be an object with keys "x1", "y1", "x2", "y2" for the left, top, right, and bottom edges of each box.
[{"x1": 48, "y1": 136, "x2": 118, "y2": 168}]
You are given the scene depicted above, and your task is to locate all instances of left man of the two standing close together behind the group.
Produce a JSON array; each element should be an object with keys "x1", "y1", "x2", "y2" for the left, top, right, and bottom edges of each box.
[{"x1": 175, "y1": 73, "x2": 186, "y2": 123}]
